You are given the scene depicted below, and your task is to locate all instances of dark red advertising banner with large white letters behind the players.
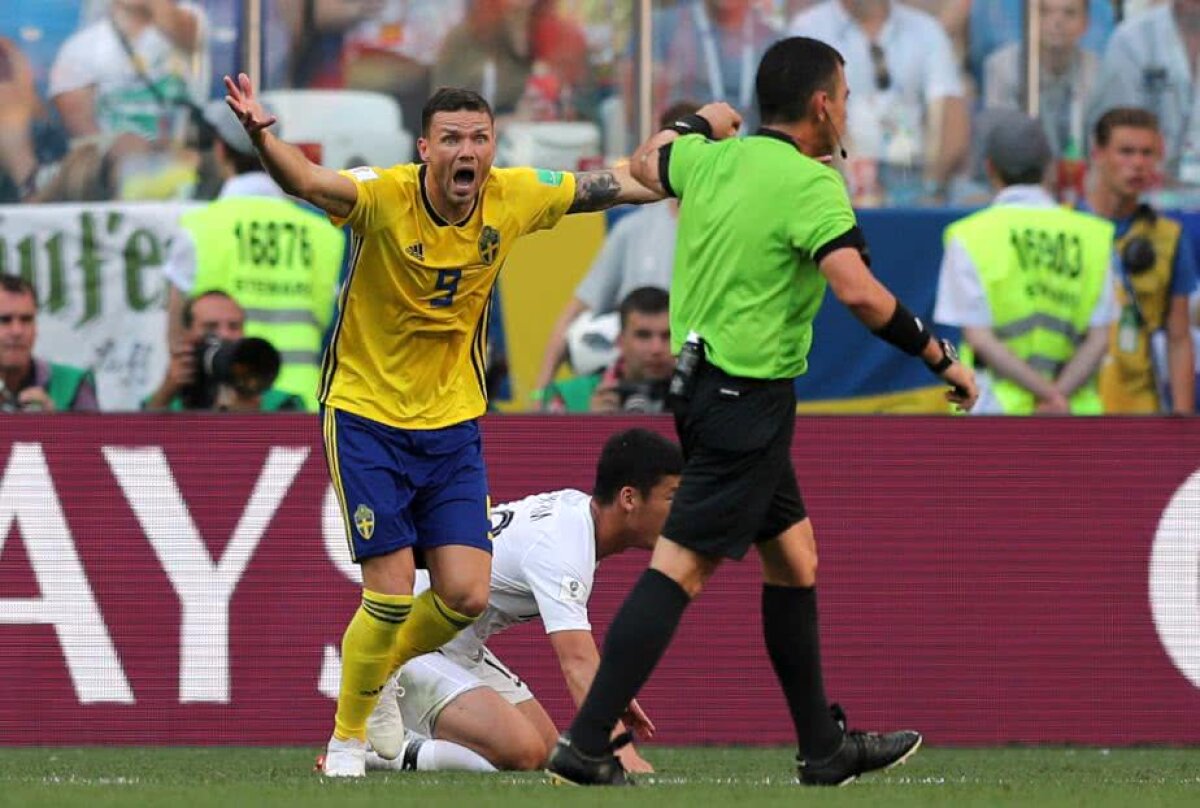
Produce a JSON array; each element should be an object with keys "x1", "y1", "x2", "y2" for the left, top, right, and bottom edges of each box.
[{"x1": 0, "y1": 415, "x2": 1200, "y2": 746}]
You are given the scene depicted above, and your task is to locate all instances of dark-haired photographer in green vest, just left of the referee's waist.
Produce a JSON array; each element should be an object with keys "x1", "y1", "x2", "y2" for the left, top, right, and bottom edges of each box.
[{"x1": 542, "y1": 286, "x2": 674, "y2": 413}]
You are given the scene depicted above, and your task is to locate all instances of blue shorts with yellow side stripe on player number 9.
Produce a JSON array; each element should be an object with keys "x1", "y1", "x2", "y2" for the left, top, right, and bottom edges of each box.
[{"x1": 322, "y1": 407, "x2": 492, "y2": 562}]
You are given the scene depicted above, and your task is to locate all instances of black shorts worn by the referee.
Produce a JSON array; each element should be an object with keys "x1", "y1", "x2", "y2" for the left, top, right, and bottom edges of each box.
[{"x1": 662, "y1": 363, "x2": 806, "y2": 559}]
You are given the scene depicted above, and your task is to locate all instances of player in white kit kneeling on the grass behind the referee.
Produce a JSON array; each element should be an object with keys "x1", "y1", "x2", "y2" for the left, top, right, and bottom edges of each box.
[{"x1": 367, "y1": 429, "x2": 683, "y2": 772}]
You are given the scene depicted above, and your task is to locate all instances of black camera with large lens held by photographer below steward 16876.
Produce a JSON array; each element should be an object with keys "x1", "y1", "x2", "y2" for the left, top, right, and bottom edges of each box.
[{"x1": 179, "y1": 334, "x2": 282, "y2": 409}]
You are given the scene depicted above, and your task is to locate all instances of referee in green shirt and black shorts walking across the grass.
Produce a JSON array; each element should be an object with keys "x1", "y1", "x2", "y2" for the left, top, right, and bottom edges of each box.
[{"x1": 548, "y1": 37, "x2": 977, "y2": 785}]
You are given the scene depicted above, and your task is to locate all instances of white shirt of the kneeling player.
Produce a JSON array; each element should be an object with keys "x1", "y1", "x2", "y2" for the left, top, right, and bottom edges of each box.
[{"x1": 413, "y1": 489, "x2": 596, "y2": 658}]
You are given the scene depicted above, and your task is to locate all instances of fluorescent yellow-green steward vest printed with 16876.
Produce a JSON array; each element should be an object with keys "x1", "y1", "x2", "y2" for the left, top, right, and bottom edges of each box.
[{"x1": 181, "y1": 197, "x2": 346, "y2": 411}]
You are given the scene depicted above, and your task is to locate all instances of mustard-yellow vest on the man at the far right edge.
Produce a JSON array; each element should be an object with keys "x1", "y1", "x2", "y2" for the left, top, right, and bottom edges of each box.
[{"x1": 1099, "y1": 210, "x2": 1183, "y2": 413}]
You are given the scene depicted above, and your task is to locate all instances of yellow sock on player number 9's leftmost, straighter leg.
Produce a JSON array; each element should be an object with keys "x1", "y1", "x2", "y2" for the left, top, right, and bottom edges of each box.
[{"x1": 334, "y1": 589, "x2": 413, "y2": 740}]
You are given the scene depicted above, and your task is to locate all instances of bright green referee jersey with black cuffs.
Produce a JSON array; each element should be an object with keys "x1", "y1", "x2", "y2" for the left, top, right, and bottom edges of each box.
[{"x1": 659, "y1": 128, "x2": 864, "y2": 379}]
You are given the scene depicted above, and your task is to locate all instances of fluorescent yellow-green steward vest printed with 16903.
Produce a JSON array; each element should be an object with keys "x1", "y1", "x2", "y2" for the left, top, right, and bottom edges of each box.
[{"x1": 944, "y1": 205, "x2": 1114, "y2": 415}]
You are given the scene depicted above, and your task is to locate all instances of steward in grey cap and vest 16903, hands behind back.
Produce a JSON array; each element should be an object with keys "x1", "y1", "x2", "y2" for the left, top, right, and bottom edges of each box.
[{"x1": 934, "y1": 110, "x2": 1117, "y2": 415}]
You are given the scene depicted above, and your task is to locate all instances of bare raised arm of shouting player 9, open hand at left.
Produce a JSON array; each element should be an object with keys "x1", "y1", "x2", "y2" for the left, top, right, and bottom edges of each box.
[{"x1": 224, "y1": 73, "x2": 359, "y2": 219}]
